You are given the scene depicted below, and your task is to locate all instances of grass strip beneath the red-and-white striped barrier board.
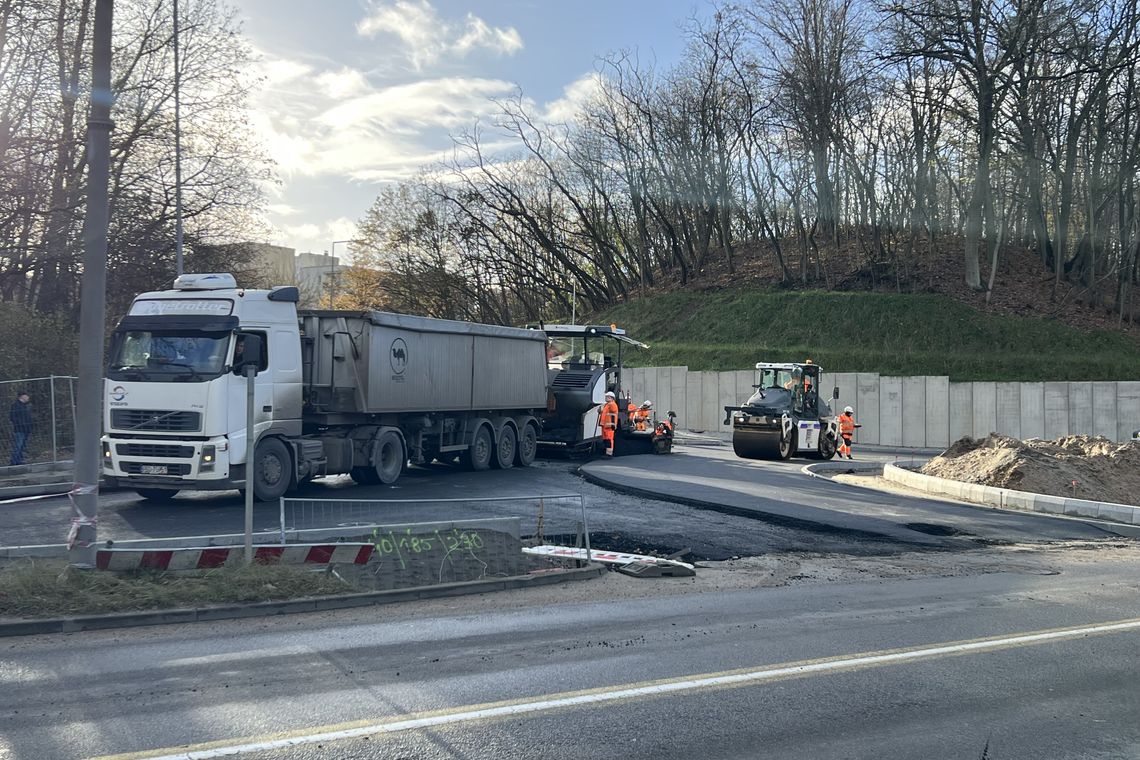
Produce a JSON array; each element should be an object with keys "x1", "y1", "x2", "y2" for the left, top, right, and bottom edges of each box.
[{"x1": 0, "y1": 559, "x2": 360, "y2": 618}]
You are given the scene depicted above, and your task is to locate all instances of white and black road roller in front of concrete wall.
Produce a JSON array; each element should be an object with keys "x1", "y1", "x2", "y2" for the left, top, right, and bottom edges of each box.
[{"x1": 724, "y1": 362, "x2": 839, "y2": 459}]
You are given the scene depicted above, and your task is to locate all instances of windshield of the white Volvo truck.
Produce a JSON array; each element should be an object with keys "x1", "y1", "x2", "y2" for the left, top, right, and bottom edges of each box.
[{"x1": 107, "y1": 330, "x2": 230, "y2": 383}]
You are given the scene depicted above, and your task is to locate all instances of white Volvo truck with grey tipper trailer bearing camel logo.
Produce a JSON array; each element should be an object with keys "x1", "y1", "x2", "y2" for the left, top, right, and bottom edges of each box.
[{"x1": 103, "y1": 275, "x2": 547, "y2": 500}]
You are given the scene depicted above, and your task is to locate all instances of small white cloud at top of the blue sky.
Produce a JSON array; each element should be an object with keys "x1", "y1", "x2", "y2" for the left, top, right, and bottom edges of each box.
[{"x1": 357, "y1": 0, "x2": 522, "y2": 71}]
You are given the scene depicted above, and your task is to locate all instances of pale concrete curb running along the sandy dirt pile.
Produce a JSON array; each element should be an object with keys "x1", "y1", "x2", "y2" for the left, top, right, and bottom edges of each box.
[{"x1": 882, "y1": 464, "x2": 1140, "y2": 525}]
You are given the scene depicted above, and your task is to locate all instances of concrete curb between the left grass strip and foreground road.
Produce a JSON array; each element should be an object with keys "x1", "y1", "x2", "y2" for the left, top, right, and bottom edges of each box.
[{"x1": 0, "y1": 563, "x2": 608, "y2": 637}]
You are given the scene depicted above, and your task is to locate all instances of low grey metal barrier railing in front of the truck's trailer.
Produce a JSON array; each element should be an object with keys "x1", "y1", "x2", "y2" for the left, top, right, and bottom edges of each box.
[{"x1": 277, "y1": 493, "x2": 589, "y2": 556}]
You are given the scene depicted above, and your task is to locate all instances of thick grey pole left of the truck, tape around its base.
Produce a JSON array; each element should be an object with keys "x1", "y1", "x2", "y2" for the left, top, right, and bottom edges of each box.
[{"x1": 67, "y1": 0, "x2": 114, "y2": 567}]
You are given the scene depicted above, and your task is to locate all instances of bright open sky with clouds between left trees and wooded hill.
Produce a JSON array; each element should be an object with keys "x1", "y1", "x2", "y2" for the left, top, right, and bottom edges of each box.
[{"x1": 237, "y1": 0, "x2": 708, "y2": 258}]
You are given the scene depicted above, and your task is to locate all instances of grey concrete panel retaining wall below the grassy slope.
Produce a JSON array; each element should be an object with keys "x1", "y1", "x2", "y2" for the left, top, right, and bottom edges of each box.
[{"x1": 625, "y1": 367, "x2": 1140, "y2": 449}]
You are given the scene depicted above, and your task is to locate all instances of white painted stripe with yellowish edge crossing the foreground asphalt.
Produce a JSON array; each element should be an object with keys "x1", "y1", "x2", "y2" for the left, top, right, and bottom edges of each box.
[{"x1": 96, "y1": 618, "x2": 1140, "y2": 760}]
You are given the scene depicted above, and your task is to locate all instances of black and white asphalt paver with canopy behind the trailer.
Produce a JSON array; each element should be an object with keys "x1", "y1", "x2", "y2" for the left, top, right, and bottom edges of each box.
[{"x1": 531, "y1": 325, "x2": 651, "y2": 455}]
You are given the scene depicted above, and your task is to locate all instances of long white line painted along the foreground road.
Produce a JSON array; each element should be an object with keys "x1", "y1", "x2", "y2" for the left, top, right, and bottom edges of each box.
[{"x1": 93, "y1": 619, "x2": 1140, "y2": 760}]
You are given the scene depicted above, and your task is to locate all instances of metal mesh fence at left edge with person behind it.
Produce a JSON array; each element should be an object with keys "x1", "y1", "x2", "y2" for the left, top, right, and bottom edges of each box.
[{"x1": 0, "y1": 375, "x2": 76, "y2": 467}]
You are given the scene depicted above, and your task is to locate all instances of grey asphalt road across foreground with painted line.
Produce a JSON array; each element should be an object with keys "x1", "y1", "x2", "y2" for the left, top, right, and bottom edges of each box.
[{"x1": 0, "y1": 551, "x2": 1140, "y2": 760}]
